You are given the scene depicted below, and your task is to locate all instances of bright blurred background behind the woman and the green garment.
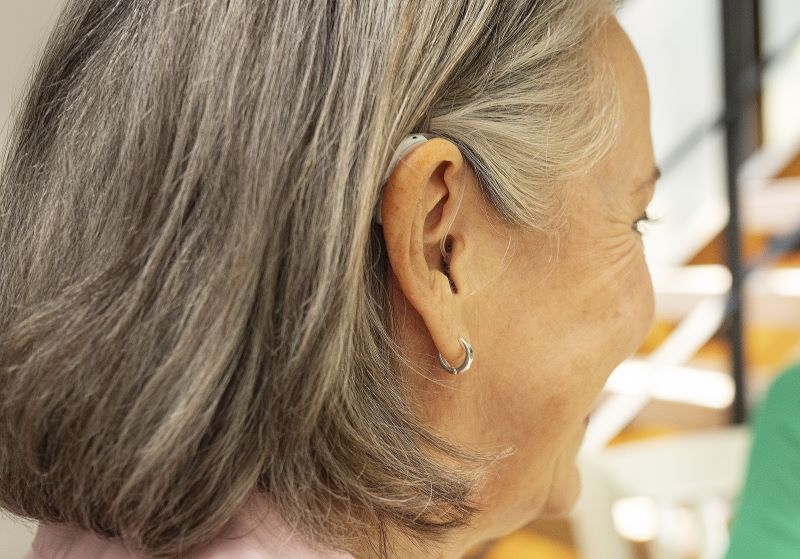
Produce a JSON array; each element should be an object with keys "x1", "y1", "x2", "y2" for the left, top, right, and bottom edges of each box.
[{"x1": 0, "y1": 0, "x2": 800, "y2": 559}]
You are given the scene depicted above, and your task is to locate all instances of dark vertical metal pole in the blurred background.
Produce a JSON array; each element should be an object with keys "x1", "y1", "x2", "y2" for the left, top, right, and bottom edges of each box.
[{"x1": 720, "y1": 0, "x2": 760, "y2": 423}]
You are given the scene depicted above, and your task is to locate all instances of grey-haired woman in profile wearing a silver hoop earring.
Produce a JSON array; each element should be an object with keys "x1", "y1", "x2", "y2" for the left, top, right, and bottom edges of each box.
[{"x1": 0, "y1": 0, "x2": 656, "y2": 559}]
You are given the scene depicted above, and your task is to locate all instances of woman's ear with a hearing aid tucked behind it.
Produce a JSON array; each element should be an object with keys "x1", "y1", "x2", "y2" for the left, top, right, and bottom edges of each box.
[{"x1": 381, "y1": 138, "x2": 470, "y2": 372}]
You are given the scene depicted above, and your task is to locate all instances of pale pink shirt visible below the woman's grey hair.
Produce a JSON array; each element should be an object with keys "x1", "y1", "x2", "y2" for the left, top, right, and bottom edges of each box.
[{"x1": 24, "y1": 493, "x2": 354, "y2": 559}]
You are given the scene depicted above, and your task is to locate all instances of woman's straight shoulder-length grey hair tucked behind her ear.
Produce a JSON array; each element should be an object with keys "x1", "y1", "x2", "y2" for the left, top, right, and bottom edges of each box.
[{"x1": 0, "y1": 0, "x2": 617, "y2": 557}]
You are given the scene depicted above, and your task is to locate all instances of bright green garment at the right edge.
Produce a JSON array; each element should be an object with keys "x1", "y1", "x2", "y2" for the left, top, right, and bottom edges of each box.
[{"x1": 726, "y1": 363, "x2": 800, "y2": 559}]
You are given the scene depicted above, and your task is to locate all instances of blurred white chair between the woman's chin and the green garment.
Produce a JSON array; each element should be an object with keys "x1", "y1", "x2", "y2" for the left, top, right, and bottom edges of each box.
[{"x1": 571, "y1": 425, "x2": 760, "y2": 559}]
